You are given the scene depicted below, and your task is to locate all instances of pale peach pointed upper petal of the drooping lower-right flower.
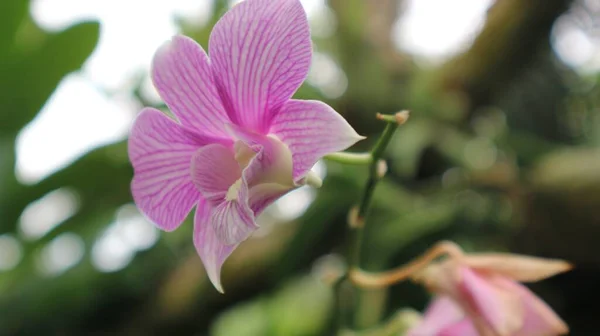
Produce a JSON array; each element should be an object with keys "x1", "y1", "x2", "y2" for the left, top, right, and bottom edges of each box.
[{"x1": 463, "y1": 253, "x2": 572, "y2": 282}]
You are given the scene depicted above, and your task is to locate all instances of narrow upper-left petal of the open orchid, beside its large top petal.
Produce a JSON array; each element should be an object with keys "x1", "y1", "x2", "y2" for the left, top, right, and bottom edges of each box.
[{"x1": 152, "y1": 36, "x2": 230, "y2": 137}]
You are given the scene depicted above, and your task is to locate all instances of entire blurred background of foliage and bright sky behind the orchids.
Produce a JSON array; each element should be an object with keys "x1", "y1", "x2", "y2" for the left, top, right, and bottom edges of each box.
[{"x1": 0, "y1": 0, "x2": 600, "y2": 336}]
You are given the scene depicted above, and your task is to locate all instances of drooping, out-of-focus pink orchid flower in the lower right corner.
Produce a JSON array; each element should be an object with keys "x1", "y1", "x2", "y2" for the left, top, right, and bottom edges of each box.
[{"x1": 408, "y1": 254, "x2": 571, "y2": 336}]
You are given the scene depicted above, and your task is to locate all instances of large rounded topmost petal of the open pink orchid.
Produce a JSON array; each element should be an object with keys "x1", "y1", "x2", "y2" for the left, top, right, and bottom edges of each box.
[{"x1": 209, "y1": 0, "x2": 312, "y2": 132}]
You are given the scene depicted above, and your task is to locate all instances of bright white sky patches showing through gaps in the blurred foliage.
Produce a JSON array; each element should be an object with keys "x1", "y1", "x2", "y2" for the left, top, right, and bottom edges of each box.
[{"x1": 0, "y1": 0, "x2": 600, "y2": 274}]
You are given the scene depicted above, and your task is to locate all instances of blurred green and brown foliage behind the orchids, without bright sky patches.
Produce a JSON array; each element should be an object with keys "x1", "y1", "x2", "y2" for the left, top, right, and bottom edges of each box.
[{"x1": 0, "y1": 0, "x2": 600, "y2": 336}]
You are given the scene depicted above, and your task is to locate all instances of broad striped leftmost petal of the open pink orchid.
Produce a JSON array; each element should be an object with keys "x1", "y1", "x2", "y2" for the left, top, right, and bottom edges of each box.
[{"x1": 128, "y1": 108, "x2": 209, "y2": 231}]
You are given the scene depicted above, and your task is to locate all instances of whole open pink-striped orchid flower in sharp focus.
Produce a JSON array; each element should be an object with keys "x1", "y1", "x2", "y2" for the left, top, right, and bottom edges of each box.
[{"x1": 129, "y1": 0, "x2": 362, "y2": 292}]
